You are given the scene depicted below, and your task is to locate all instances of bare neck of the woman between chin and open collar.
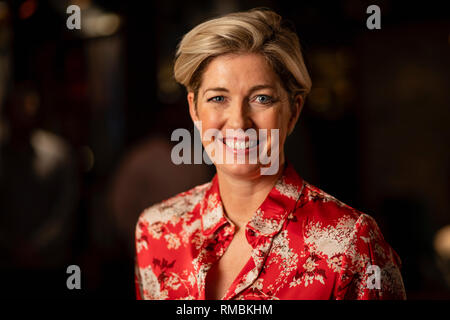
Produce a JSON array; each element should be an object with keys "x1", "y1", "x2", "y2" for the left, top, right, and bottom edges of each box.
[{"x1": 217, "y1": 164, "x2": 284, "y2": 230}]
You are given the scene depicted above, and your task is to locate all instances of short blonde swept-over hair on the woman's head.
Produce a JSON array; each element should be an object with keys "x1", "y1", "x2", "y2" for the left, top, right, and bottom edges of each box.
[{"x1": 174, "y1": 9, "x2": 311, "y2": 104}]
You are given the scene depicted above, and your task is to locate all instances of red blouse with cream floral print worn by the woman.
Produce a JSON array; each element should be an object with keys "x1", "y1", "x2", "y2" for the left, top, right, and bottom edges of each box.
[{"x1": 135, "y1": 164, "x2": 406, "y2": 300}]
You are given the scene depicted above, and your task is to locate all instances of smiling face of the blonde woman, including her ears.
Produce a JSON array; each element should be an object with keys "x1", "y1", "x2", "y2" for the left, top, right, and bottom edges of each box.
[{"x1": 188, "y1": 54, "x2": 302, "y2": 178}]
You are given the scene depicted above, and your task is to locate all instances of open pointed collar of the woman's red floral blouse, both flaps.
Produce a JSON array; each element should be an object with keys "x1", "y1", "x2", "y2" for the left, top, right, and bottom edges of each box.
[{"x1": 201, "y1": 162, "x2": 304, "y2": 237}]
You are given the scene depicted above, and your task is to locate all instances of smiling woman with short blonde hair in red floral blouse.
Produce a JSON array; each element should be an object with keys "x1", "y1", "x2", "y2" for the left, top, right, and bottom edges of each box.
[{"x1": 135, "y1": 9, "x2": 405, "y2": 299}]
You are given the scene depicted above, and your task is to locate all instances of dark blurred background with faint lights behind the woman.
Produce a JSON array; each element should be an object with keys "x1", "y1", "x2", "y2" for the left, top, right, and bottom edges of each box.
[{"x1": 0, "y1": 0, "x2": 450, "y2": 299}]
